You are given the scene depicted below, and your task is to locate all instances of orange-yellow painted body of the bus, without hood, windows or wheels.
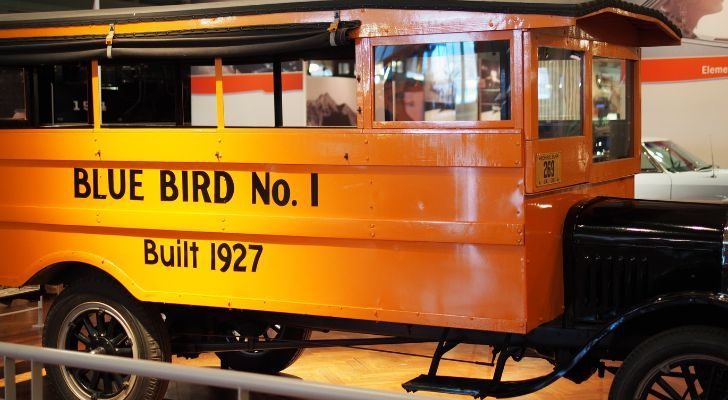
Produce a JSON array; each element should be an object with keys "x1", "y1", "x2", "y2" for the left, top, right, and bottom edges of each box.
[{"x1": 0, "y1": 3, "x2": 677, "y2": 333}]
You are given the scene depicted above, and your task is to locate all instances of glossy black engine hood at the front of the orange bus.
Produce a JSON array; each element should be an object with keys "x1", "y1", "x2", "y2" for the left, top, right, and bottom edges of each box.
[{"x1": 563, "y1": 197, "x2": 728, "y2": 328}]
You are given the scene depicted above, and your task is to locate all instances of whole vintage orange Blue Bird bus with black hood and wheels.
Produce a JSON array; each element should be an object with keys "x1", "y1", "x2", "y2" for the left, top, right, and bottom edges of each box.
[{"x1": 0, "y1": 0, "x2": 728, "y2": 399}]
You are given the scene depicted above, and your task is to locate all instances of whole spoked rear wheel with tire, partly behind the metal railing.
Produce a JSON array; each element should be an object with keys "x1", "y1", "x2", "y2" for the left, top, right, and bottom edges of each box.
[{"x1": 43, "y1": 280, "x2": 170, "y2": 400}]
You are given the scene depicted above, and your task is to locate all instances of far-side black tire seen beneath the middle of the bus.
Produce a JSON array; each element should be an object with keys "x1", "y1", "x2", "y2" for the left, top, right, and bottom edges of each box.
[{"x1": 215, "y1": 327, "x2": 311, "y2": 375}]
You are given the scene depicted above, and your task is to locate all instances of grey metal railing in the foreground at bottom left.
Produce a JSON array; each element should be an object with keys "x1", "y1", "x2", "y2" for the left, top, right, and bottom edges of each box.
[{"x1": 0, "y1": 342, "x2": 438, "y2": 400}]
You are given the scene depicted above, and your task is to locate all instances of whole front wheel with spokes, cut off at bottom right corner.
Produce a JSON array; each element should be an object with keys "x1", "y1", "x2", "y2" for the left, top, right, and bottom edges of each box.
[{"x1": 609, "y1": 326, "x2": 728, "y2": 400}]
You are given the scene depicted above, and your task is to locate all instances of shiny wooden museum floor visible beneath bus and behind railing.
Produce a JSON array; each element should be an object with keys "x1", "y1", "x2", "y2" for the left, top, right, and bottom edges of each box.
[{"x1": 0, "y1": 300, "x2": 611, "y2": 400}]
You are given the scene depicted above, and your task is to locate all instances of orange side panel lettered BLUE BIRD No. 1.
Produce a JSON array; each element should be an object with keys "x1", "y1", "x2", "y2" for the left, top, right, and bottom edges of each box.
[{"x1": 0, "y1": 162, "x2": 523, "y2": 245}]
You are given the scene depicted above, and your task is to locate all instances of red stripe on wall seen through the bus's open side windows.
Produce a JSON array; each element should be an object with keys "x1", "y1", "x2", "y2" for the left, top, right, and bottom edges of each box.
[{"x1": 190, "y1": 72, "x2": 303, "y2": 94}]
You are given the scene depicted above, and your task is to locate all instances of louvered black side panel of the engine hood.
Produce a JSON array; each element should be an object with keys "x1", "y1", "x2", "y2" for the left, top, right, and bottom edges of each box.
[{"x1": 572, "y1": 254, "x2": 649, "y2": 322}]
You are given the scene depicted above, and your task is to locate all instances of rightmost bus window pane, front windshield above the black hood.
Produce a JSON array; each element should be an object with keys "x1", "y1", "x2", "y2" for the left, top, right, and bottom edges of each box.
[{"x1": 592, "y1": 57, "x2": 634, "y2": 162}]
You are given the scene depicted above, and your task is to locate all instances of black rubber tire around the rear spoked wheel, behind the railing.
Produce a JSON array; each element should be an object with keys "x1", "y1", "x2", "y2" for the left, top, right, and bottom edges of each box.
[{"x1": 43, "y1": 279, "x2": 171, "y2": 400}]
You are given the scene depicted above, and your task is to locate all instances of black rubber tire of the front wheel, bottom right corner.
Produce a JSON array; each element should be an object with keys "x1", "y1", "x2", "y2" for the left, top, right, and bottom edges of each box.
[{"x1": 609, "y1": 326, "x2": 728, "y2": 400}]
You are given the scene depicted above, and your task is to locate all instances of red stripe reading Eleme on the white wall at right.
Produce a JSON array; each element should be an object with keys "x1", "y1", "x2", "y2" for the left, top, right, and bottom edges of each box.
[{"x1": 642, "y1": 56, "x2": 728, "y2": 83}]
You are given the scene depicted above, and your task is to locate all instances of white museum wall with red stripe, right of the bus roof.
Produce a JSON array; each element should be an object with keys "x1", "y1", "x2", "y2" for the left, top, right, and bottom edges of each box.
[{"x1": 631, "y1": 0, "x2": 728, "y2": 167}]
